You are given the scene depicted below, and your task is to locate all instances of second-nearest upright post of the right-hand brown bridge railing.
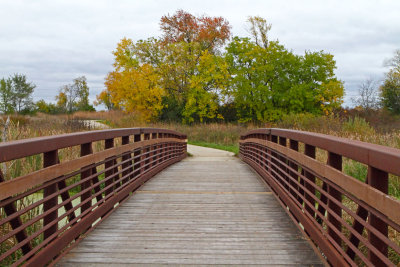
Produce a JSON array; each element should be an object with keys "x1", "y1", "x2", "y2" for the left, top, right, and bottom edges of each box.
[{"x1": 328, "y1": 152, "x2": 342, "y2": 245}]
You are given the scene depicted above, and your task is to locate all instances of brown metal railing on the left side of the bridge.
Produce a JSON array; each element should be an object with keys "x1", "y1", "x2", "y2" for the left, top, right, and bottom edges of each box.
[{"x1": 0, "y1": 128, "x2": 186, "y2": 266}]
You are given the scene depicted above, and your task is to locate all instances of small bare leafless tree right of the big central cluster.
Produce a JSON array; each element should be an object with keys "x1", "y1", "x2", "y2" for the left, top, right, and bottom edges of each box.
[{"x1": 352, "y1": 78, "x2": 379, "y2": 111}]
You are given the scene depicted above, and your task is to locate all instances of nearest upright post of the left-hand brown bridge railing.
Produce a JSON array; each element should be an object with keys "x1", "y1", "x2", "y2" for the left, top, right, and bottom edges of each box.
[{"x1": 43, "y1": 150, "x2": 58, "y2": 240}]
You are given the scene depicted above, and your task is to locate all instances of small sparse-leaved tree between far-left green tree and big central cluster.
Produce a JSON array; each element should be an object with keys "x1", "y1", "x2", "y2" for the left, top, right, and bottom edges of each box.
[{"x1": 56, "y1": 76, "x2": 95, "y2": 113}]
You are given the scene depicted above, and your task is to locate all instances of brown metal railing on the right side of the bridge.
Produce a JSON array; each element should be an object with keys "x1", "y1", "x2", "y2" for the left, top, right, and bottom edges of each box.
[{"x1": 240, "y1": 129, "x2": 400, "y2": 266}]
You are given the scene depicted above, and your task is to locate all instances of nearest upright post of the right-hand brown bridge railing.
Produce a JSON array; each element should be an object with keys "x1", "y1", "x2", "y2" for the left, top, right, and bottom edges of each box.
[{"x1": 368, "y1": 166, "x2": 389, "y2": 266}]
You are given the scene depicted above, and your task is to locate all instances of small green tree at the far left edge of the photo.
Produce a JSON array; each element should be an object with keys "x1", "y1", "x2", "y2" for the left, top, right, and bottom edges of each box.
[{"x1": 0, "y1": 74, "x2": 36, "y2": 114}]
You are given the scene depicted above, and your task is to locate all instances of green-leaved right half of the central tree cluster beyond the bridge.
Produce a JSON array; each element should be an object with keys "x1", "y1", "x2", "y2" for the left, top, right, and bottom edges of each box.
[{"x1": 226, "y1": 37, "x2": 344, "y2": 122}]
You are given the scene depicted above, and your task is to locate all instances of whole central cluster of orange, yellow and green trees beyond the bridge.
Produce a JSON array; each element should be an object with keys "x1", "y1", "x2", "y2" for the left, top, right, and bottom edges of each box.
[{"x1": 97, "y1": 10, "x2": 344, "y2": 123}]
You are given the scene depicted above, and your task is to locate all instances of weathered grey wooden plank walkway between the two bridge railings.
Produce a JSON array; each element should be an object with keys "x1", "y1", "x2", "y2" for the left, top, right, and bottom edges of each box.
[{"x1": 58, "y1": 146, "x2": 322, "y2": 266}]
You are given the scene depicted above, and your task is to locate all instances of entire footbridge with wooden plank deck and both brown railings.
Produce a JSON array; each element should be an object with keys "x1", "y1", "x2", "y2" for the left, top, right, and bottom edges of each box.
[{"x1": 0, "y1": 128, "x2": 400, "y2": 266}]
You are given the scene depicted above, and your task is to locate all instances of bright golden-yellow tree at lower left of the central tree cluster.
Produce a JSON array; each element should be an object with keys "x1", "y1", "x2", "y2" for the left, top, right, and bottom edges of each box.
[{"x1": 105, "y1": 64, "x2": 164, "y2": 121}]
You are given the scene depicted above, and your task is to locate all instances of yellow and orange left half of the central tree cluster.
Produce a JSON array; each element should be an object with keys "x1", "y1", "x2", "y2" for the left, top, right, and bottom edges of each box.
[{"x1": 98, "y1": 10, "x2": 230, "y2": 122}]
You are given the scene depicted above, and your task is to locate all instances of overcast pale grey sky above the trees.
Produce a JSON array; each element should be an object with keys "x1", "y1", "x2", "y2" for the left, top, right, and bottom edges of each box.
[{"x1": 0, "y1": 0, "x2": 400, "y2": 109}]
